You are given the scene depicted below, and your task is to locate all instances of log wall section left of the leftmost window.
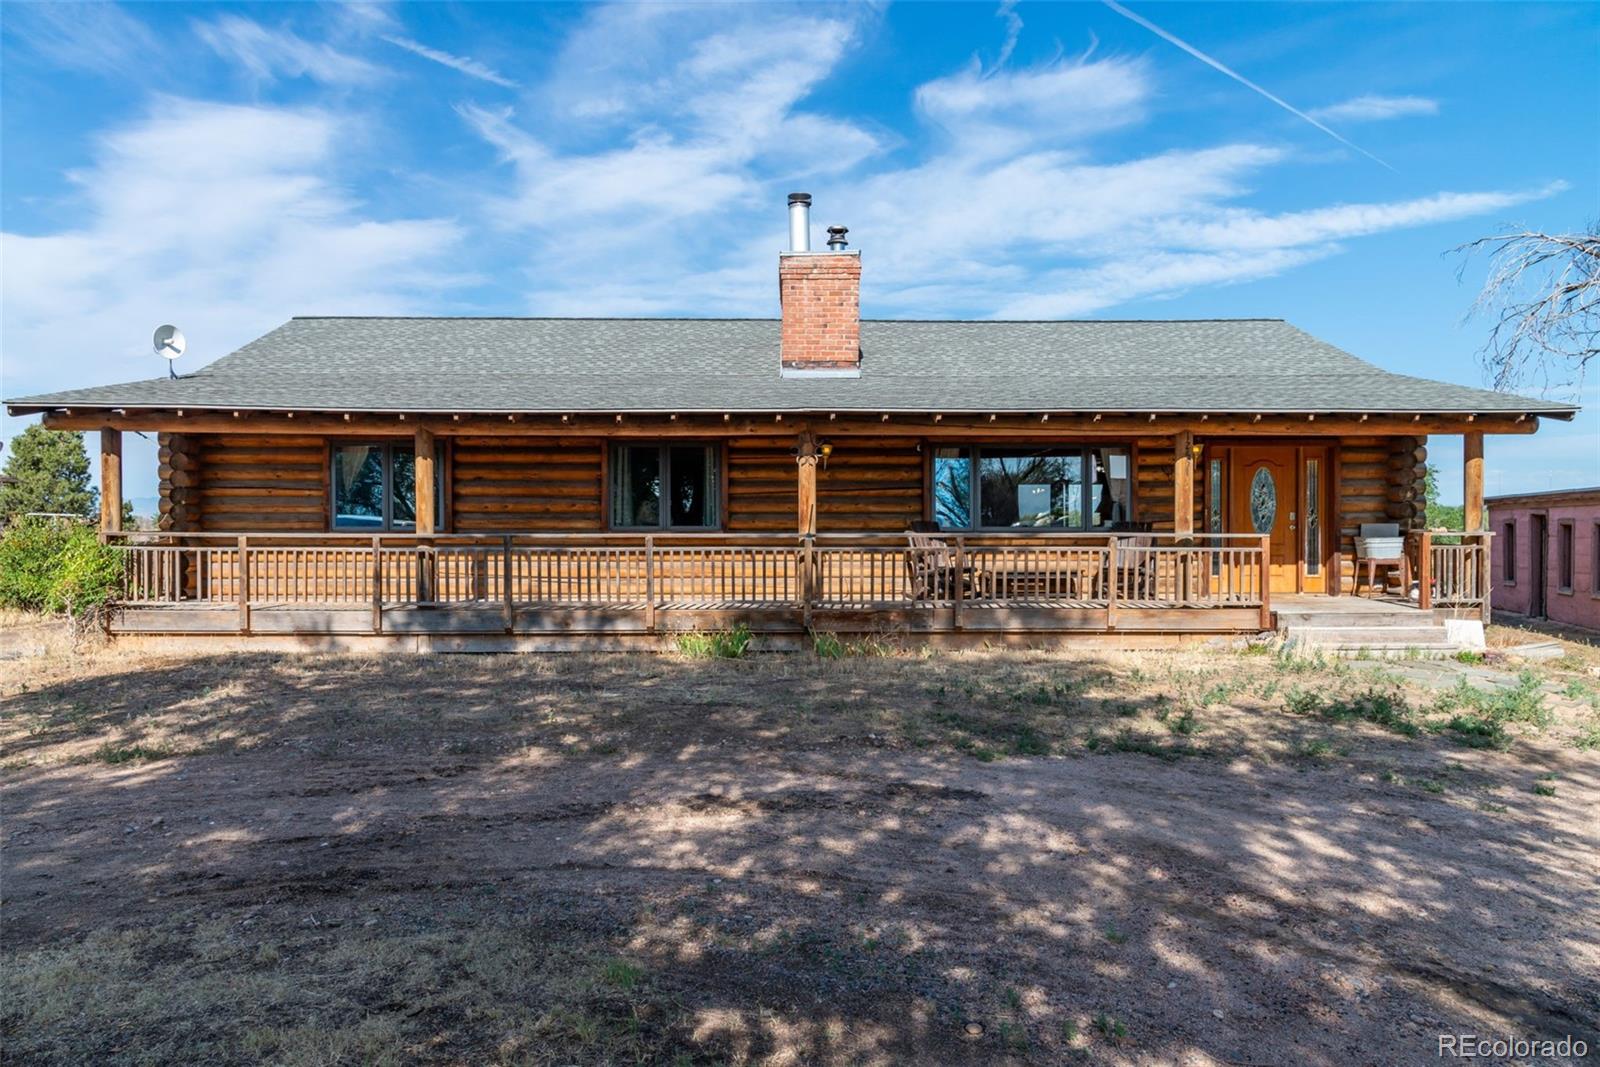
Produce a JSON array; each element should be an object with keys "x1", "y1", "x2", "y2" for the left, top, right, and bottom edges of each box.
[{"x1": 184, "y1": 434, "x2": 330, "y2": 533}]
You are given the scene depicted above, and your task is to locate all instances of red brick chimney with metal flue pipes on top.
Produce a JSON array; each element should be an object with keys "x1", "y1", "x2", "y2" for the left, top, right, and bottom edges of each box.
[{"x1": 778, "y1": 192, "x2": 861, "y2": 378}]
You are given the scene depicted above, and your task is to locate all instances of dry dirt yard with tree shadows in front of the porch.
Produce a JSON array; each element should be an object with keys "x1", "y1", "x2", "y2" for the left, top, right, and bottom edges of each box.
[{"x1": 0, "y1": 630, "x2": 1600, "y2": 1065}]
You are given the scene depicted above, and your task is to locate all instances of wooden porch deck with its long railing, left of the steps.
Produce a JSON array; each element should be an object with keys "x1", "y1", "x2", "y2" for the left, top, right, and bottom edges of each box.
[{"x1": 110, "y1": 534, "x2": 1270, "y2": 646}]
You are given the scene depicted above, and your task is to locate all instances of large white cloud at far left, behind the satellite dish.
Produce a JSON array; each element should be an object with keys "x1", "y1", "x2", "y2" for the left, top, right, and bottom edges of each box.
[{"x1": 0, "y1": 98, "x2": 464, "y2": 395}]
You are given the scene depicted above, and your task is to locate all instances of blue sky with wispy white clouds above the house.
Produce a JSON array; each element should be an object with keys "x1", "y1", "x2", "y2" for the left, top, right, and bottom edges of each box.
[{"x1": 0, "y1": 3, "x2": 1600, "y2": 499}]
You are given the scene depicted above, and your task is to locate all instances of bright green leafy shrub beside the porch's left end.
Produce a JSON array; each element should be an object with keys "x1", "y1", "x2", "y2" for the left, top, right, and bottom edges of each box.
[{"x1": 0, "y1": 518, "x2": 122, "y2": 625}]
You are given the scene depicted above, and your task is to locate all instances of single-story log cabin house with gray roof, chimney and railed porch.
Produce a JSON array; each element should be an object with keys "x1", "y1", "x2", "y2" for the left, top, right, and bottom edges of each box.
[{"x1": 6, "y1": 194, "x2": 1574, "y2": 649}]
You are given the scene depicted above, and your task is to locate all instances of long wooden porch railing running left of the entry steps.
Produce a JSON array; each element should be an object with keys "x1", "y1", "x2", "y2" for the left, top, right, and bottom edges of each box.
[{"x1": 114, "y1": 533, "x2": 1269, "y2": 632}]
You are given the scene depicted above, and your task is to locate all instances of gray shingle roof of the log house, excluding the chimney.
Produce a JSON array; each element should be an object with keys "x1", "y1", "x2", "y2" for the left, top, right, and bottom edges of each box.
[{"x1": 6, "y1": 318, "x2": 1574, "y2": 416}]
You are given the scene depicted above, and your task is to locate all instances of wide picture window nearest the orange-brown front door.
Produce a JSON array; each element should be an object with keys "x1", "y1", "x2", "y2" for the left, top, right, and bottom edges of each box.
[{"x1": 933, "y1": 446, "x2": 1133, "y2": 530}]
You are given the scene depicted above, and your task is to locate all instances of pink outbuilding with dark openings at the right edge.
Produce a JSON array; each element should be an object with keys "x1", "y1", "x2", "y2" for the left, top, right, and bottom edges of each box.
[{"x1": 1486, "y1": 486, "x2": 1600, "y2": 632}]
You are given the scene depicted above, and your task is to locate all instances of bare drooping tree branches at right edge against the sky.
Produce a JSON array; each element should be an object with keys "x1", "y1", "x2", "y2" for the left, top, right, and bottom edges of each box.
[{"x1": 1451, "y1": 222, "x2": 1600, "y2": 390}]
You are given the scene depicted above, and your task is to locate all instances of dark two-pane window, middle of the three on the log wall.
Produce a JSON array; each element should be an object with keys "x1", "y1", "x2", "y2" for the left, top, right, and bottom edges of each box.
[{"x1": 611, "y1": 445, "x2": 722, "y2": 530}]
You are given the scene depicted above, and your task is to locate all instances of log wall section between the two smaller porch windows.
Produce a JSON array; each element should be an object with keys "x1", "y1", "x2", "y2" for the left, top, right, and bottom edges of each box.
[{"x1": 450, "y1": 437, "x2": 606, "y2": 533}]
